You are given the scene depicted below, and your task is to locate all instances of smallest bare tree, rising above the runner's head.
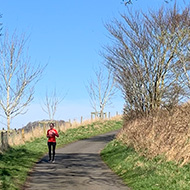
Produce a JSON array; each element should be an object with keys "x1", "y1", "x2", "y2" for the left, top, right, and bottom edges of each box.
[{"x1": 42, "y1": 89, "x2": 65, "y2": 121}]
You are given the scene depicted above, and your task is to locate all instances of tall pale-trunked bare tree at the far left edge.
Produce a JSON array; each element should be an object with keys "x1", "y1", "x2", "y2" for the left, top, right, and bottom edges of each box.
[{"x1": 0, "y1": 33, "x2": 45, "y2": 131}]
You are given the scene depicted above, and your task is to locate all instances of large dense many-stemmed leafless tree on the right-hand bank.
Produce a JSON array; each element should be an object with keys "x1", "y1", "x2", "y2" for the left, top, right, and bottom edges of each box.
[{"x1": 103, "y1": 4, "x2": 190, "y2": 119}]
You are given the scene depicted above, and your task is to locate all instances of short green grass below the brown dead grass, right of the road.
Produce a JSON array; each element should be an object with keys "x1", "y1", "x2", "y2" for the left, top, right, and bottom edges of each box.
[{"x1": 101, "y1": 140, "x2": 190, "y2": 190}]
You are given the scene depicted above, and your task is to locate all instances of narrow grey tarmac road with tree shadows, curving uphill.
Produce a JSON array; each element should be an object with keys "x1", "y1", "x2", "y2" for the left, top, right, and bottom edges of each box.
[{"x1": 24, "y1": 132, "x2": 129, "y2": 190}]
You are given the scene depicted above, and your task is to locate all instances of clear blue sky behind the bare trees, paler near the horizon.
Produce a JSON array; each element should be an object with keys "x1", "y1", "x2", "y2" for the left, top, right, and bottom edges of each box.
[{"x1": 0, "y1": 0, "x2": 187, "y2": 129}]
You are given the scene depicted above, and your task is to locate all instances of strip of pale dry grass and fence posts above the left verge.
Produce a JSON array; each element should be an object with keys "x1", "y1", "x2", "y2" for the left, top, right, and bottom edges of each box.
[{"x1": 0, "y1": 113, "x2": 121, "y2": 152}]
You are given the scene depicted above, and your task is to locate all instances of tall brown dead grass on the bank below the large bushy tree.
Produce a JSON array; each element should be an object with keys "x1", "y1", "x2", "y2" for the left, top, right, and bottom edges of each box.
[{"x1": 117, "y1": 103, "x2": 190, "y2": 165}]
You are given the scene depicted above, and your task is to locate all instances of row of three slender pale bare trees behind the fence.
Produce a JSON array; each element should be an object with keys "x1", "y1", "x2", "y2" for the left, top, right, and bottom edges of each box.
[{"x1": 0, "y1": 33, "x2": 115, "y2": 131}]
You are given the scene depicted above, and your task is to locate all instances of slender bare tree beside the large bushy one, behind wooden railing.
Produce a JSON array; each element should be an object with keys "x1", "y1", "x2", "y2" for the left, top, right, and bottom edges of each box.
[{"x1": 86, "y1": 68, "x2": 116, "y2": 118}]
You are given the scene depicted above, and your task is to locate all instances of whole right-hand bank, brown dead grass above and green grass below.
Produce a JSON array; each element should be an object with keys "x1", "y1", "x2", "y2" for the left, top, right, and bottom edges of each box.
[{"x1": 101, "y1": 104, "x2": 190, "y2": 190}]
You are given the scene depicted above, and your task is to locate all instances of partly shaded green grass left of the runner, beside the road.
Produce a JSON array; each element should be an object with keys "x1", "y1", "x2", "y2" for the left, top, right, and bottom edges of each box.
[{"x1": 0, "y1": 138, "x2": 47, "y2": 189}]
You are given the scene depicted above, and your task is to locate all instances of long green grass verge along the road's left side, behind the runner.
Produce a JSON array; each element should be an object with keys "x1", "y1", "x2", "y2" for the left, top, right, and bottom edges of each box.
[{"x1": 0, "y1": 121, "x2": 122, "y2": 190}]
